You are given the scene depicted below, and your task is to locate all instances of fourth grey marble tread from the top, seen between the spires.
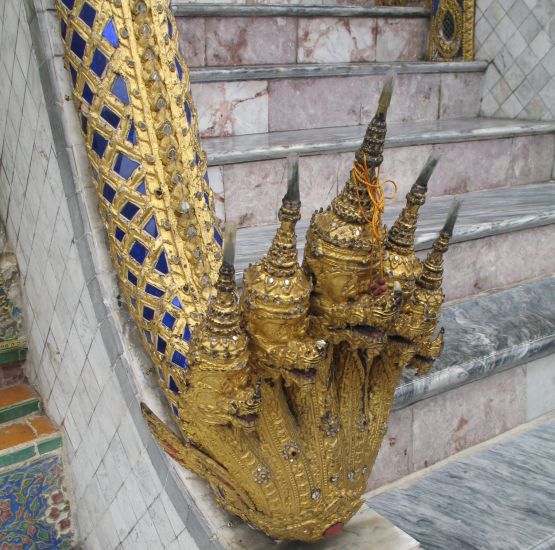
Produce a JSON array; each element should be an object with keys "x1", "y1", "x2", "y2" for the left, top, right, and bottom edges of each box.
[{"x1": 235, "y1": 181, "x2": 555, "y2": 281}]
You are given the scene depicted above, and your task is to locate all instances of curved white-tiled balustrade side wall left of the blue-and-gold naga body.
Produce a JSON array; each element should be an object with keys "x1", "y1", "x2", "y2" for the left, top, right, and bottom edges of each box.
[{"x1": 0, "y1": 0, "x2": 215, "y2": 550}]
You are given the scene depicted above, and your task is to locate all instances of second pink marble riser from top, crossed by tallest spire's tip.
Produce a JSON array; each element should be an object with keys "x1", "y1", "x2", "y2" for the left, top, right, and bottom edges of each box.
[{"x1": 192, "y1": 72, "x2": 482, "y2": 137}]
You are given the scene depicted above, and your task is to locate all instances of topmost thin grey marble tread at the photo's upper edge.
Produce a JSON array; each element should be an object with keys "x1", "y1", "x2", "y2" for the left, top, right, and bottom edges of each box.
[{"x1": 171, "y1": 0, "x2": 430, "y2": 17}]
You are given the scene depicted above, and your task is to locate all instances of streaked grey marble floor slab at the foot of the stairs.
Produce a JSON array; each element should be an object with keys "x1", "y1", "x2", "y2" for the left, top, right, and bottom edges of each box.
[{"x1": 367, "y1": 419, "x2": 555, "y2": 550}]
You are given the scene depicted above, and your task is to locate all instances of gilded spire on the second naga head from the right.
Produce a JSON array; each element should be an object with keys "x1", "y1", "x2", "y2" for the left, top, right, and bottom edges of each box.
[{"x1": 385, "y1": 154, "x2": 439, "y2": 254}]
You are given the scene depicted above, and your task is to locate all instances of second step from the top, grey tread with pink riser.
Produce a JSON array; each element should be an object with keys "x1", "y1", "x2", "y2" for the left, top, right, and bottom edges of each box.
[{"x1": 191, "y1": 61, "x2": 487, "y2": 137}]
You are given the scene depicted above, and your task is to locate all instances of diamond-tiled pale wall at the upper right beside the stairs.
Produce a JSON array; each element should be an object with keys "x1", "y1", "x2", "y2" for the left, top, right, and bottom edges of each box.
[{"x1": 476, "y1": 0, "x2": 555, "y2": 120}]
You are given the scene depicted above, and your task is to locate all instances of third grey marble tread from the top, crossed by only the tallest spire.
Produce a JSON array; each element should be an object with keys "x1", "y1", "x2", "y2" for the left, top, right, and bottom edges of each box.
[{"x1": 203, "y1": 117, "x2": 555, "y2": 166}]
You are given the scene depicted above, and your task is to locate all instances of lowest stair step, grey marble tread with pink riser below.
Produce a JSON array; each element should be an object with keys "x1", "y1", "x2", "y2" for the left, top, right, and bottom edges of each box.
[{"x1": 369, "y1": 277, "x2": 555, "y2": 492}]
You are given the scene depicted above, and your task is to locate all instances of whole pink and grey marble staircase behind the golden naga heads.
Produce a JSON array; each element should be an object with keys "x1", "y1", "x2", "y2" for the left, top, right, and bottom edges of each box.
[{"x1": 172, "y1": 0, "x2": 555, "y2": 496}]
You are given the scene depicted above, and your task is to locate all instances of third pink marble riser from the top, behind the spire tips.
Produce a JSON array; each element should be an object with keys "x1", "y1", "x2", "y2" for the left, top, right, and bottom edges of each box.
[{"x1": 218, "y1": 135, "x2": 555, "y2": 227}]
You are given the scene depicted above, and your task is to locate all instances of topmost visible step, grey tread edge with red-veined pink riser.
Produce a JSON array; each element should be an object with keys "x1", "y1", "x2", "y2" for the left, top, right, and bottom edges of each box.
[{"x1": 173, "y1": 1, "x2": 429, "y2": 67}]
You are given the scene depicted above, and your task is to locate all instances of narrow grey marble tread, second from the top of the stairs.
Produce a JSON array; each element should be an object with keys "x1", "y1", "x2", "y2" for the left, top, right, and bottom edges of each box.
[{"x1": 191, "y1": 61, "x2": 488, "y2": 83}]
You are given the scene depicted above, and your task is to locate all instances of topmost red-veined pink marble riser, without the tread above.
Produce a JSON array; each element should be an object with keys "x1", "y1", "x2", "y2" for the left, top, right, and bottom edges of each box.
[{"x1": 177, "y1": 17, "x2": 428, "y2": 67}]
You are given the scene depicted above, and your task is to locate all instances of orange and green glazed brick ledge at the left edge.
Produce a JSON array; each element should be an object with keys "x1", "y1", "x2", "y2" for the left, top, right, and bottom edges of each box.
[{"x1": 0, "y1": 416, "x2": 62, "y2": 469}]
